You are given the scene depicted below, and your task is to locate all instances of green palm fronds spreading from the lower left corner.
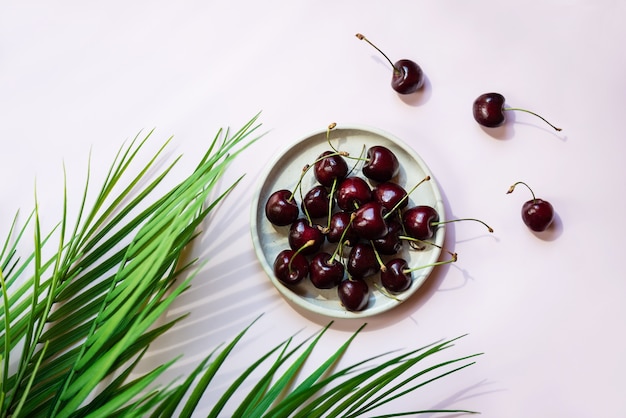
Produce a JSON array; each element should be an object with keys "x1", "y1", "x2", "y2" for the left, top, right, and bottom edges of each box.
[{"x1": 0, "y1": 115, "x2": 482, "y2": 417}]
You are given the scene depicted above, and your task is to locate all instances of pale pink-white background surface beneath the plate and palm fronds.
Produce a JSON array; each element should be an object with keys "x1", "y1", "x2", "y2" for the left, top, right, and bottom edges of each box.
[{"x1": 0, "y1": 0, "x2": 626, "y2": 418}]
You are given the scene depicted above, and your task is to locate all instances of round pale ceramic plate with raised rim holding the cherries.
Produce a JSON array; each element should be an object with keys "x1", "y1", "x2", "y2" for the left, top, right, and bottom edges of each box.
[{"x1": 250, "y1": 125, "x2": 445, "y2": 318}]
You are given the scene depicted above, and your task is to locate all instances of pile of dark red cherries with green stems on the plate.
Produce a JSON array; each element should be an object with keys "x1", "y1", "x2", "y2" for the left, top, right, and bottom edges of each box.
[{"x1": 265, "y1": 129, "x2": 464, "y2": 311}]
